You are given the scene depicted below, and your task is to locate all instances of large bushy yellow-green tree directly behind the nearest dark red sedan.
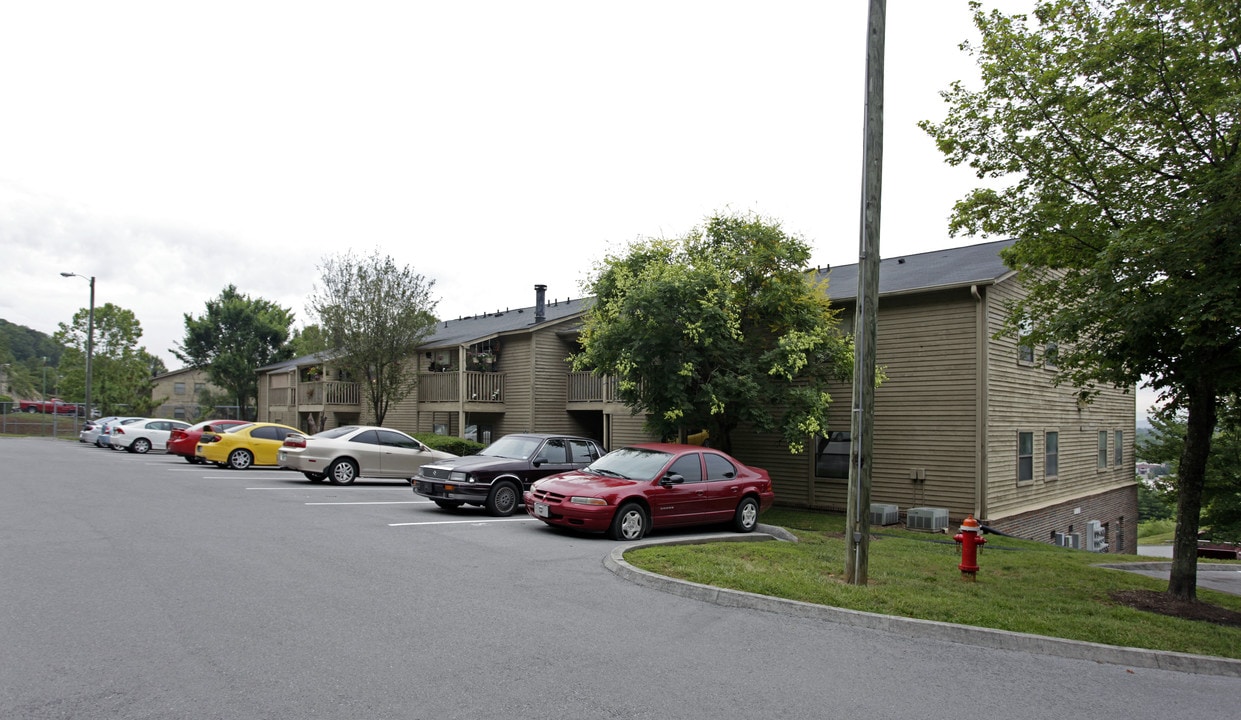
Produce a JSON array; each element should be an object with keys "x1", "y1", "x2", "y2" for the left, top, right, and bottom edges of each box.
[{"x1": 572, "y1": 215, "x2": 853, "y2": 452}]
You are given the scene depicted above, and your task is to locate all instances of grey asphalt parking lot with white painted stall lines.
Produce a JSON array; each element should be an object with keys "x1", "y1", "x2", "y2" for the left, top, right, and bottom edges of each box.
[{"x1": 7, "y1": 438, "x2": 1241, "y2": 720}]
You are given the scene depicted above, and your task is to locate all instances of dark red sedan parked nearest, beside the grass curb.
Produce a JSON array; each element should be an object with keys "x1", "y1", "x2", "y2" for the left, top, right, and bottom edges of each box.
[{"x1": 524, "y1": 443, "x2": 776, "y2": 540}]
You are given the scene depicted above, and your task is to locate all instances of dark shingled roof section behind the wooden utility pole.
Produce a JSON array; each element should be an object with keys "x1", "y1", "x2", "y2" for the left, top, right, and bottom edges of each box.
[{"x1": 815, "y1": 238, "x2": 1016, "y2": 302}]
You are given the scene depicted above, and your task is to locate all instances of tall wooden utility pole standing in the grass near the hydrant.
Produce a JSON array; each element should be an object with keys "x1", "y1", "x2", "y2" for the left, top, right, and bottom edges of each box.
[{"x1": 845, "y1": 0, "x2": 887, "y2": 585}]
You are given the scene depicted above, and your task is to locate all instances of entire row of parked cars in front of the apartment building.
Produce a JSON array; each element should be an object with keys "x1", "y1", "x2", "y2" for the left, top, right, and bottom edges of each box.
[{"x1": 89, "y1": 418, "x2": 774, "y2": 540}]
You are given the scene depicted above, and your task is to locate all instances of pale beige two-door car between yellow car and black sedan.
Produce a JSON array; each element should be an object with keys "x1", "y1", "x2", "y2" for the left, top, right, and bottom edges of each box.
[{"x1": 276, "y1": 425, "x2": 457, "y2": 485}]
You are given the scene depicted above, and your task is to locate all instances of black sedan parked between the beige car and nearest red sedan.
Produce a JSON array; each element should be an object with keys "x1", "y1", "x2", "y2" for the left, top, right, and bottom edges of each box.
[{"x1": 410, "y1": 433, "x2": 607, "y2": 518}]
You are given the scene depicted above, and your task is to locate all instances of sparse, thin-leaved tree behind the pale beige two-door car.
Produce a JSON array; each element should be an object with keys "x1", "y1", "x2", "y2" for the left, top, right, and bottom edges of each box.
[{"x1": 309, "y1": 251, "x2": 438, "y2": 425}]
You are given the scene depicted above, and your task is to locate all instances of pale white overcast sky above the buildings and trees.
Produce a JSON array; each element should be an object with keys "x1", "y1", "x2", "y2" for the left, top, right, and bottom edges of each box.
[{"x1": 7, "y1": 0, "x2": 1151, "y2": 409}]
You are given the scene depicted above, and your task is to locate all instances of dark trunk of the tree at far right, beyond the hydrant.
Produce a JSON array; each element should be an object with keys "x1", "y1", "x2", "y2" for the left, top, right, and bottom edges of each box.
[{"x1": 1168, "y1": 380, "x2": 1216, "y2": 600}]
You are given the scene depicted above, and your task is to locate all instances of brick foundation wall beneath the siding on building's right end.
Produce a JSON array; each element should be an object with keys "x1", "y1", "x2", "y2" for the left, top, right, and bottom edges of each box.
[{"x1": 983, "y1": 485, "x2": 1138, "y2": 555}]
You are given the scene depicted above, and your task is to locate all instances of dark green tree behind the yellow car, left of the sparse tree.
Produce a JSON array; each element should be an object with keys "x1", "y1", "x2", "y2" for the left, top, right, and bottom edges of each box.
[{"x1": 172, "y1": 284, "x2": 293, "y2": 417}]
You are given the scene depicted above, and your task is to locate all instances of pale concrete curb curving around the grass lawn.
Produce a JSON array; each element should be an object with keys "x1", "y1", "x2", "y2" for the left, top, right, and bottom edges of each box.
[{"x1": 603, "y1": 525, "x2": 1241, "y2": 678}]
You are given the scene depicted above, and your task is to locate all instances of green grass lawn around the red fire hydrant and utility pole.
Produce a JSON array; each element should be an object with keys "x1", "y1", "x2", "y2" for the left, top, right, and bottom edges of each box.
[{"x1": 625, "y1": 508, "x2": 1241, "y2": 659}]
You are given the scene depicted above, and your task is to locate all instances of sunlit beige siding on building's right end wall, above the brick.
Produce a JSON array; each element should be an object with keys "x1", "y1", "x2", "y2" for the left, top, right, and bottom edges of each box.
[{"x1": 984, "y1": 282, "x2": 1136, "y2": 520}]
